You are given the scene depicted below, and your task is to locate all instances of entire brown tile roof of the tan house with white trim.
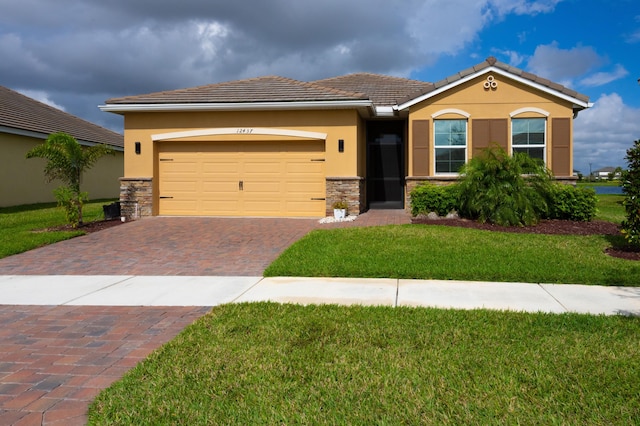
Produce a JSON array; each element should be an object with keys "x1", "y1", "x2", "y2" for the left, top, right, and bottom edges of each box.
[{"x1": 101, "y1": 57, "x2": 589, "y2": 111}]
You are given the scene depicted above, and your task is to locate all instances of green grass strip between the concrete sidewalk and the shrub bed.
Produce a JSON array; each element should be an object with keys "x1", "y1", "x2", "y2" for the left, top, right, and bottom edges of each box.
[{"x1": 264, "y1": 225, "x2": 640, "y2": 286}]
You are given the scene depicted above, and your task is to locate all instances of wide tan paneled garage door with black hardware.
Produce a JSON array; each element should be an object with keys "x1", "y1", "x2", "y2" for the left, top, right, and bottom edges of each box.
[{"x1": 158, "y1": 140, "x2": 326, "y2": 217}]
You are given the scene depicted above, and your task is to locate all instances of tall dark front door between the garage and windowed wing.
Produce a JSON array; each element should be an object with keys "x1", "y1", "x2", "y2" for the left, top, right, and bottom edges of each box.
[{"x1": 367, "y1": 121, "x2": 405, "y2": 209}]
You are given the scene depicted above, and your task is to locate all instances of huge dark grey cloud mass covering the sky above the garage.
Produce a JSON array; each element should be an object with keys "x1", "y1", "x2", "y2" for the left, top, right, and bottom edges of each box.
[{"x1": 0, "y1": 0, "x2": 558, "y2": 131}]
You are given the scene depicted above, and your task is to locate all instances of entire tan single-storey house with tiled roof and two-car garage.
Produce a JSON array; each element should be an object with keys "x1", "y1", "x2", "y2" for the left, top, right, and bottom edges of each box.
[{"x1": 100, "y1": 58, "x2": 592, "y2": 221}]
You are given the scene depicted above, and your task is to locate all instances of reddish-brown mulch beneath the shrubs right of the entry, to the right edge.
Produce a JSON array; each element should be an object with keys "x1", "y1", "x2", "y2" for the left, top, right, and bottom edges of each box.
[{"x1": 411, "y1": 218, "x2": 640, "y2": 260}]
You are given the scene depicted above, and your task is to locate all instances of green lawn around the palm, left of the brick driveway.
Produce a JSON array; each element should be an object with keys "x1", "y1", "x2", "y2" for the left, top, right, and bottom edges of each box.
[{"x1": 0, "y1": 200, "x2": 113, "y2": 258}]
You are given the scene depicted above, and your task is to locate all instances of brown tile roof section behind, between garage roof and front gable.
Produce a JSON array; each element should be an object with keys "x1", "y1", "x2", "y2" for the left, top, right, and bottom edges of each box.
[{"x1": 313, "y1": 73, "x2": 432, "y2": 106}]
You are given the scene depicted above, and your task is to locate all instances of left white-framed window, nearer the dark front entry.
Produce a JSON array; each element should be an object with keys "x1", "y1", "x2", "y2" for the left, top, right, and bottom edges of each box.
[{"x1": 433, "y1": 120, "x2": 467, "y2": 174}]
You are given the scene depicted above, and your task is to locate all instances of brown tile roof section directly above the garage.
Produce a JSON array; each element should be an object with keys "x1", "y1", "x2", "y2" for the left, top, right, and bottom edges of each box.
[{"x1": 106, "y1": 76, "x2": 368, "y2": 104}]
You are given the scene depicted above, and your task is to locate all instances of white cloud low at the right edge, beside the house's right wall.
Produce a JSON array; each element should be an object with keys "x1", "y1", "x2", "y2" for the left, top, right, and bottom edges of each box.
[{"x1": 573, "y1": 93, "x2": 640, "y2": 174}]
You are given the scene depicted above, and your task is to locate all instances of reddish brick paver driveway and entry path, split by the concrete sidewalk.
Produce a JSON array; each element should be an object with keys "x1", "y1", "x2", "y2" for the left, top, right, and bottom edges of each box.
[{"x1": 0, "y1": 211, "x2": 409, "y2": 426}]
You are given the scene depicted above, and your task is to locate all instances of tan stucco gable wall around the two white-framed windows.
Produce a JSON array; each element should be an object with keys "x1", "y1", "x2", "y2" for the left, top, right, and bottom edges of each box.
[{"x1": 408, "y1": 73, "x2": 573, "y2": 176}]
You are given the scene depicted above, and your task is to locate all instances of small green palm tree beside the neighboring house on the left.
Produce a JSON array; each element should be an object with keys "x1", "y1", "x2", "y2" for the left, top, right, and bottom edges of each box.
[{"x1": 27, "y1": 132, "x2": 115, "y2": 226}]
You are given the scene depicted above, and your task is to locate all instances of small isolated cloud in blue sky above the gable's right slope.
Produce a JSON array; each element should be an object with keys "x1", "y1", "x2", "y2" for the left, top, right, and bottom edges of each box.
[{"x1": 527, "y1": 41, "x2": 605, "y2": 85}]
